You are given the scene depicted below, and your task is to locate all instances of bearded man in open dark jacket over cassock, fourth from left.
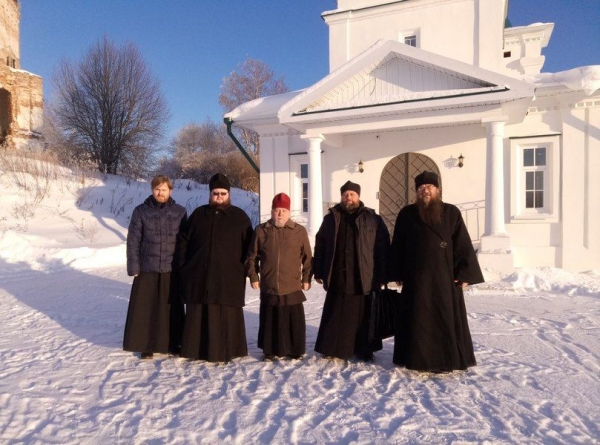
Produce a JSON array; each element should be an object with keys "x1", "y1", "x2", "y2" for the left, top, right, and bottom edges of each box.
[{"x1": 313, "y1": 181, "x2": 390, "y2": 361}]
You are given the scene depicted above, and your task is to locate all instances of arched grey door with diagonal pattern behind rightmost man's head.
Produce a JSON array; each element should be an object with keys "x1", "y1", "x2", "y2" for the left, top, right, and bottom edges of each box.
[{"x1": 379, "y1": 153, "x2": 442, "y2": 234}]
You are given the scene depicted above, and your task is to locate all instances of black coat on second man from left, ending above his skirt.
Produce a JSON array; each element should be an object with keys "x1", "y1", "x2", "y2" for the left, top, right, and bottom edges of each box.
[{"x1": 175, "y1": 205, "x2": 252, "y2": 307}]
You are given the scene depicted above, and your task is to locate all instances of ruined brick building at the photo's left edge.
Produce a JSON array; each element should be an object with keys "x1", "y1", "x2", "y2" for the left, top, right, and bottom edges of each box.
[{"x1": 0, "y1": 0, "x2": 44, "y2": 149}]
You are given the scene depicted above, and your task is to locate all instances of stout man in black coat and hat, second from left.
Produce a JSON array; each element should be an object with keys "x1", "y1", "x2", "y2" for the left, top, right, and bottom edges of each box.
[{"x1": 176, "y1": 173, "x2": 252, "y2": 363}]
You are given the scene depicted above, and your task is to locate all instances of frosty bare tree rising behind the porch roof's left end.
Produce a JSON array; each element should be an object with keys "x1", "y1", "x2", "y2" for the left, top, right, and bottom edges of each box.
[{"x1": 219, "y1": 58, "x2": 289, "y2": 161}]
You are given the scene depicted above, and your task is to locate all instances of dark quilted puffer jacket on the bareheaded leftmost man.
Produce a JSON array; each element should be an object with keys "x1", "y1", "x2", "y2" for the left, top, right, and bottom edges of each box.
[{"x1": 127, "y1": 195, "x2": 187, "y2": 276}]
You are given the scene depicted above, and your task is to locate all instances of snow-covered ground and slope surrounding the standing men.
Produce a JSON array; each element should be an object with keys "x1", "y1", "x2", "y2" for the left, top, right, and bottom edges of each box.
[{"x1": 0, "y1": 155, "x2": 600, "y2": 445}]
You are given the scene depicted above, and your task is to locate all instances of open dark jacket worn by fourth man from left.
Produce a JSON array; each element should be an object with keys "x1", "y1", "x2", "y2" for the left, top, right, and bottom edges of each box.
[{"x1": 313, "y1": 202, "x2": 390, "y2": 295}]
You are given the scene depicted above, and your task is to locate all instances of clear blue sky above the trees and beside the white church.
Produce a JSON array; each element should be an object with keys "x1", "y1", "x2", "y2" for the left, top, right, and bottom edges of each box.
[{"x1": 20, "y1": 0, "x2": 600, "y2": 138}]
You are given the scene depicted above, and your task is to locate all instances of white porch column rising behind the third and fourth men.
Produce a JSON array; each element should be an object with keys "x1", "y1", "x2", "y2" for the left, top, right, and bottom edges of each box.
[{"x1": 307, "y1": 136, "x2": 323, "y2": 239}]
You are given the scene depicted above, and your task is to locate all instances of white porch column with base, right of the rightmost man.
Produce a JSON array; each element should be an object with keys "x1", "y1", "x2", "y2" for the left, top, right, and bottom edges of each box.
[{"x1": 477, "y1": 119, "x2": 514, "y2": 273}]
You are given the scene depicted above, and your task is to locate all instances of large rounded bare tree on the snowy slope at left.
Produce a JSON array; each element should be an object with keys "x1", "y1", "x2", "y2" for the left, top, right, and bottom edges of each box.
[{"x1": 54, "y1": 37, "x2": 169, "y2": 175}]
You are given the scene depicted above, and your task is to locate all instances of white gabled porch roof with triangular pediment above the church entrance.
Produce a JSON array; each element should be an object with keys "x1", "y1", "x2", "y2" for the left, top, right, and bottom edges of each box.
[{"x1": 226, "y1": 40, "x2": 535, "y2": 132}]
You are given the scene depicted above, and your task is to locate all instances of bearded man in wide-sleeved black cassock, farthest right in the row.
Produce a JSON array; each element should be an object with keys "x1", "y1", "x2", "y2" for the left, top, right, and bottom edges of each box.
[{"x1": 389, "y1": 171, "x2": 483, "y2": 372}]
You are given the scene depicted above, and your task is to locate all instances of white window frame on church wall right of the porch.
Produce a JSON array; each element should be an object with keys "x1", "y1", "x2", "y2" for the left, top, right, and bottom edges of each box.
[{"x1": 510, "y1": 135, "x2": 560, "y2": 221}]
